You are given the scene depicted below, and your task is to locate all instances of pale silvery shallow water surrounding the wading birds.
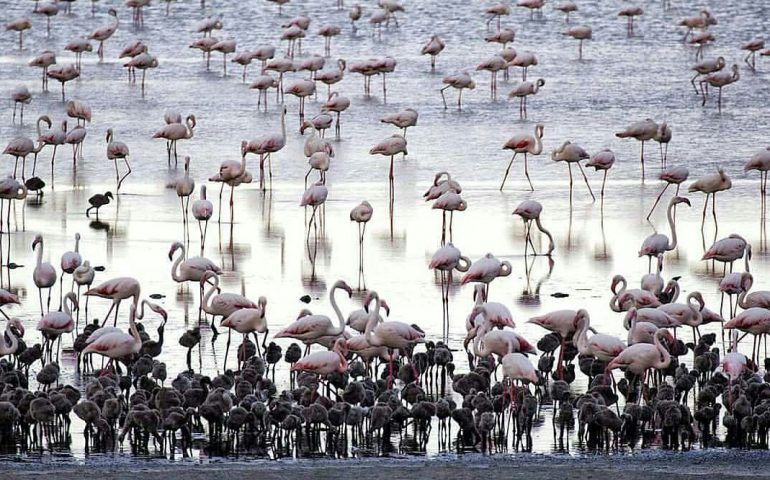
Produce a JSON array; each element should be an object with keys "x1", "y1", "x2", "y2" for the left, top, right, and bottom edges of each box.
[{"x1": 0, "y1": 0, "x2": 770, "y2": 464}]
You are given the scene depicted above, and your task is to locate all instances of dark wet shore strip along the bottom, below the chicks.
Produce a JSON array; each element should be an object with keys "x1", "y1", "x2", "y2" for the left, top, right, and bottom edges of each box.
[{"x1": 0, "y1": 450, "x2": 770, "y2": 480}]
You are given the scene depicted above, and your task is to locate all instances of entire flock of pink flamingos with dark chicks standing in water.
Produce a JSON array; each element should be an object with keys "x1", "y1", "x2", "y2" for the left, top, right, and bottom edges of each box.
[{"x1": 0, "y1": 0, "x2": 770, "y2": 462}]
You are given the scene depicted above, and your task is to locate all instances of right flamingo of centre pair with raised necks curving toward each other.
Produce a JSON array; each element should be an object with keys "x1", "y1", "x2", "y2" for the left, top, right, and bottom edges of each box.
[{"x1": 362, "y1": 290, "x2": 425, "y2": 389}]
